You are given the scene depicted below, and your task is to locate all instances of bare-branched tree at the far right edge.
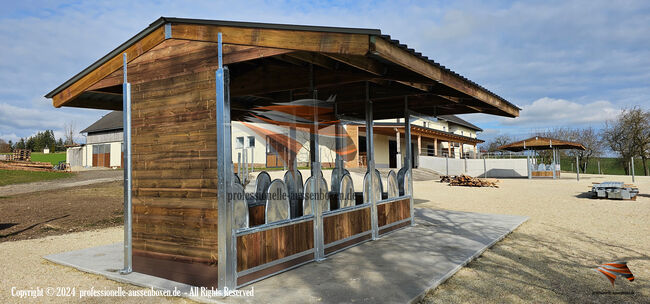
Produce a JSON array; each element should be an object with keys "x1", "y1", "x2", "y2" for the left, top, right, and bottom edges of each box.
[{"x1": 603, "y1": 107, "x2": 650, "y2": 175}]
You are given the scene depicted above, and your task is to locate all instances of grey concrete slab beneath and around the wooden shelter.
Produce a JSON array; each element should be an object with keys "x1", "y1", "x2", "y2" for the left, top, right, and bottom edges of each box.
[{"x1": 45, "y1": 208, "x2": 528, "y2": 303}]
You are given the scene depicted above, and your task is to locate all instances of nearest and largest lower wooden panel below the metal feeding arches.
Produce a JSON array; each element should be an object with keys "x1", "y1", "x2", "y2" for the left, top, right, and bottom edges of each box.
[{"x1": 237, "y1": 221, "x2": 314, "y2": 271}]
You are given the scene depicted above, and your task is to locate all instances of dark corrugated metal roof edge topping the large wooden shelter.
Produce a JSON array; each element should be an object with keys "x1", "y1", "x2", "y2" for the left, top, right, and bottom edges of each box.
[{"x1": 45, "y1": 17, "x2": 521, "y2": 110}]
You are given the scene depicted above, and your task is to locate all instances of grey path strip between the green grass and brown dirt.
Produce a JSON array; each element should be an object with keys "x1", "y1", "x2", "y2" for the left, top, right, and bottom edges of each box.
[{"x1": 0, "y1": 169, "x2": 124, "y2": 196}]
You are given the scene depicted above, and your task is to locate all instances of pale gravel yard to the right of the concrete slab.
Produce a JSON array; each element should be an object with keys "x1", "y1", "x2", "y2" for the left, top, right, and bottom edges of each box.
[{"x1": 414, "y1": 174, "x2": 650, "y2": 303}]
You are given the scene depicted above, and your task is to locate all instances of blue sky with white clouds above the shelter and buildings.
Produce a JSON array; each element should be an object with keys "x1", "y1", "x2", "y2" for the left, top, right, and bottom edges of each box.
[{"x1": 0, "y1": 0, "x2": 650, "y2": 141}]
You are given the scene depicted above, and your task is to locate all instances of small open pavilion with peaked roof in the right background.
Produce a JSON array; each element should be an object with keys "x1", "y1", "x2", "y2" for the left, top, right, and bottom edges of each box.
[{"x1": 497, "y1": 136, "x2": 585, "y2": 179}]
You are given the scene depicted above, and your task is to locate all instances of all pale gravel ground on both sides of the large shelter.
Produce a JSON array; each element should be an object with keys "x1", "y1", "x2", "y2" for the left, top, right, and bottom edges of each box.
[{"x1": 0, "y1": 172, "x2": 650, "y2": 303}]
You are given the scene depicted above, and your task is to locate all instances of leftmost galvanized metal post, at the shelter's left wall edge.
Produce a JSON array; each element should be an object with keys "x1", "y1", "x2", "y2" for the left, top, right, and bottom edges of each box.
[{"x1": 120, "y1": 53, "x2": 133, "y2": 274}]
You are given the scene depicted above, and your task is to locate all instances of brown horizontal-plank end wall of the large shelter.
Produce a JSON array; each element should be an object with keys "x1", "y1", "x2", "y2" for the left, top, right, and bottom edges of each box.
[{"x1": 131, "y1": 67, "x2": 218, "y2": 270}]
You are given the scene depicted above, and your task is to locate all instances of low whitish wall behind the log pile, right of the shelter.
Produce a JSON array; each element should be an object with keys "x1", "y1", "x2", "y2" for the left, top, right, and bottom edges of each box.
[{"x1": 419, "y1": 155, "x2": 528, "y2": 177}]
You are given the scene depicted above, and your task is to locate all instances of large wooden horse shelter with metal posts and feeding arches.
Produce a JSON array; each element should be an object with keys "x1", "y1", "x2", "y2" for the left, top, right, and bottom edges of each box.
[{"x1": 46, "y1": 18, "x2": 520, "y2": 289}]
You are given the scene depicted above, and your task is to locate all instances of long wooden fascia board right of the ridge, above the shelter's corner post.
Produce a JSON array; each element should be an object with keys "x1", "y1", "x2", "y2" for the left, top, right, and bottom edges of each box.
[{"x1": 172, "y1": 24, "x2": 370, "y2": 55}]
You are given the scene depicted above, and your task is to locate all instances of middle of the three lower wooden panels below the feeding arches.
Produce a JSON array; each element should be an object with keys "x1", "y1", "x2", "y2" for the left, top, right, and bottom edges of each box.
[{"x1": 323, "y1": 208, "x2": 371, "y2": 244}]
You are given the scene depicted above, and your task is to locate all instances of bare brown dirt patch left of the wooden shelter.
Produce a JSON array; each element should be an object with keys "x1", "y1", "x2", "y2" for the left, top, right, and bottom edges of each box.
[{"x1": 0, "y1": 181, "x2": 124, "y2": 242}]
